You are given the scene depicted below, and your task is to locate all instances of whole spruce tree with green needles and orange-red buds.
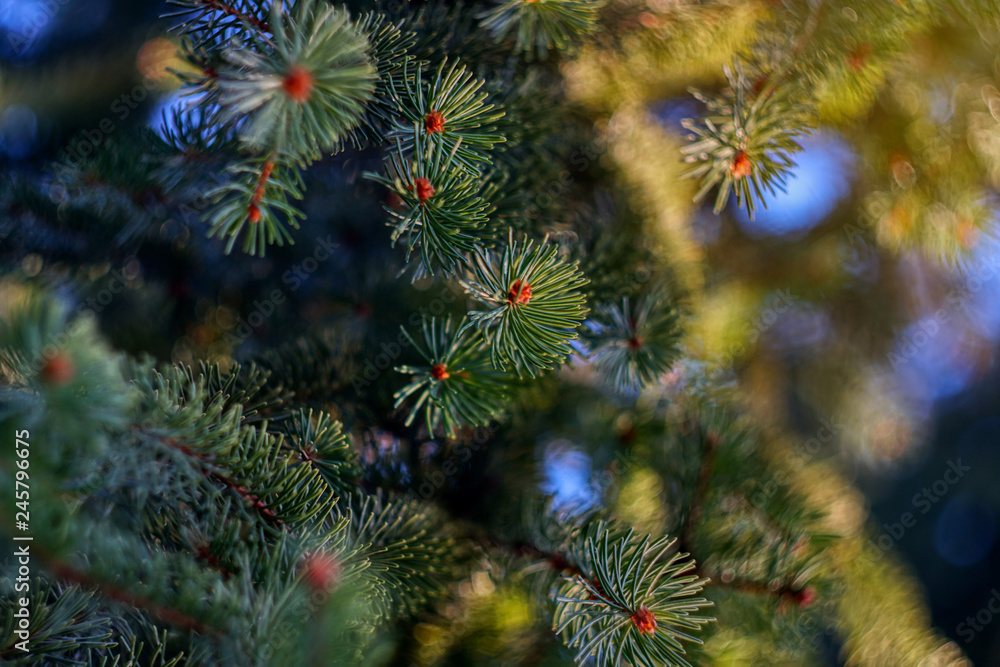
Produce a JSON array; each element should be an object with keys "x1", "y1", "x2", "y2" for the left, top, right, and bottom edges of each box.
[{"x1": 0, "y1": 0, "x2": 1000, "y2": 665}]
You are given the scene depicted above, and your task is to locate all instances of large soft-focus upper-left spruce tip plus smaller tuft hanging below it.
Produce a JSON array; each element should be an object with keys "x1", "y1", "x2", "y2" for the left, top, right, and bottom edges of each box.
[{"x1": 170, "y1": 0, "x2": 377, "y2": 255}]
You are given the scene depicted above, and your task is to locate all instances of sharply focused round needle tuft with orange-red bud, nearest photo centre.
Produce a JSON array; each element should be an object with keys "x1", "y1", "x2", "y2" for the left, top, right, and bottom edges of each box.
[{"x1": 461, "y1": 232, "x2": 588, "y2": 377}]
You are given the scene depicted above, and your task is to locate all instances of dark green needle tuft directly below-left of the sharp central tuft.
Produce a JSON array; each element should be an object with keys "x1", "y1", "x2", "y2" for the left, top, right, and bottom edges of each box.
[{"x1": 395, "y1": 318, "x2": 514, "y2": 437}]
